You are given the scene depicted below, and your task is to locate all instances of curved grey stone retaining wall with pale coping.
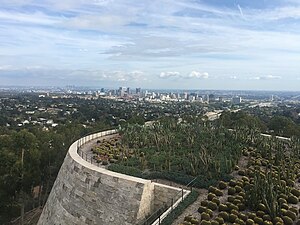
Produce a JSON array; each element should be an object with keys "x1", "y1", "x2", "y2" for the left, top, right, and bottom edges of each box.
[{"x1": 38, "y1": 130, "x2": 185, "y2": 225}]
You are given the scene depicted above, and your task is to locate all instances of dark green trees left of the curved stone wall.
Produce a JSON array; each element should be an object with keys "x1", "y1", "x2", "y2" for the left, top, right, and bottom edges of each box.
[{"x1": 0, "y1": 123, "x2": 109, "y2": 224}]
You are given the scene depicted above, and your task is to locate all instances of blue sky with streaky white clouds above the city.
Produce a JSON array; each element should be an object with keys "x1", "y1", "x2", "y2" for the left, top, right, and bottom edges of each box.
[{"x1": 0, "y1": 0, "x2": 300, "y2": 91}]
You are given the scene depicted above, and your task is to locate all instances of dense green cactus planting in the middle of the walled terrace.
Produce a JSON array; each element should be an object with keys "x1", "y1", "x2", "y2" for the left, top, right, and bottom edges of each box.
[{"x1": 110, "y1": 118, "x2": 253, "y2": 187}]
